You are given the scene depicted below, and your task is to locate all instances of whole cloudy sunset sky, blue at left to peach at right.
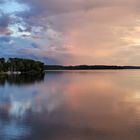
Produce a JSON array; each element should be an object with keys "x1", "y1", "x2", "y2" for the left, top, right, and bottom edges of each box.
[{"x1": 0, "y1": 0, "x2": 140, "y2": 65}]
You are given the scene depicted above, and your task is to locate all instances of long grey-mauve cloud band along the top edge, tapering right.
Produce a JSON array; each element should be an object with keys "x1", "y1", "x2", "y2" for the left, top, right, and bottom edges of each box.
[{"x1": 17, "y1": 0, "x2": 140, "y2": 17}]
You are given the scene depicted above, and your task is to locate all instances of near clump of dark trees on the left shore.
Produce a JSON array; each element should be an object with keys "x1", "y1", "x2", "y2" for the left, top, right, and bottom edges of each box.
[{"x1": 0, "y1": 58, "x2": 44, "y2": 73}]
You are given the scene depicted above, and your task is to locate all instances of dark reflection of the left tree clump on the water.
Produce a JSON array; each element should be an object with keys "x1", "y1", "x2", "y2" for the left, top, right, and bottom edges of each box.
[{"x1": 0, "y1": 74, "x2": 44, "y2": 85}]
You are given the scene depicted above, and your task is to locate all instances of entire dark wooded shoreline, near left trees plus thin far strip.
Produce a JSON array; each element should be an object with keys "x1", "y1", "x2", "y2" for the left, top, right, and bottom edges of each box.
[{"x1": 0, "y1": 58, "x2": 140, "y2": 75}]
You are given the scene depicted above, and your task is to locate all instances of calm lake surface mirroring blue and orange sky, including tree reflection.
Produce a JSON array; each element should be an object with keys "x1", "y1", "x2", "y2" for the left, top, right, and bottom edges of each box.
[{"x1": 0, "y1": 70, "x2": 140, "y2": 140}]
